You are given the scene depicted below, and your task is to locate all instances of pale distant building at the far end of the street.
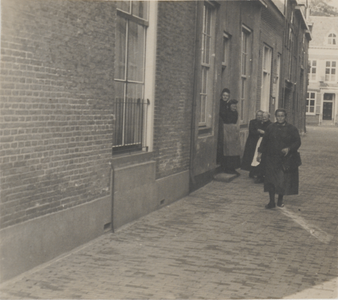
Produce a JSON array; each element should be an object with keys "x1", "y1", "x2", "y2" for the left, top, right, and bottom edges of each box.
[{"x1": 306, "y1": 16, "x2": 338, "y2": 125}]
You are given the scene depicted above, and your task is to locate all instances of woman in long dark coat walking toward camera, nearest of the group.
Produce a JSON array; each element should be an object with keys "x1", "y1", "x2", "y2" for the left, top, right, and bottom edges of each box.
[{"x1": 257, "y1": 109, "x2": 301, "y2": 208}]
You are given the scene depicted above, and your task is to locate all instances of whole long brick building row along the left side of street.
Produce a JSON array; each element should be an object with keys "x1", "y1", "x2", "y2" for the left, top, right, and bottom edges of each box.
[{"x1": 0, "y1": 0, "x2": 310, "y2": 281}]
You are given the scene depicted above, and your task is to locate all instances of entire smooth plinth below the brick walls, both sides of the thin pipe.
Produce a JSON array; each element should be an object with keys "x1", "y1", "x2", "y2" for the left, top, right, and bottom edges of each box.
[{"x1": 0, "y1": 161, "x2": 189, "y2": 282}]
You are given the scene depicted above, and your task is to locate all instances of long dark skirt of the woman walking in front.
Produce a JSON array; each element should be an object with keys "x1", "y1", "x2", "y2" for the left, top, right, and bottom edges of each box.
[{"x1": 264, "y1": 155, "x2": 299, "y2": 195}]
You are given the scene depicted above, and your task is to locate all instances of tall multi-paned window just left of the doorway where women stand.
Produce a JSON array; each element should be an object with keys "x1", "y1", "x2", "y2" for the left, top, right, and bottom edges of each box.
[{"x1": 199, "y1": 2, "x2": 215, "y2": 127}]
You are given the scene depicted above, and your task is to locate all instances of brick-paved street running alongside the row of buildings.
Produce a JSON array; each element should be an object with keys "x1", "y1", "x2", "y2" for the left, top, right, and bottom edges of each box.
[{"x1": 0, "y1": 127, "x2": 338, "y2": 299}]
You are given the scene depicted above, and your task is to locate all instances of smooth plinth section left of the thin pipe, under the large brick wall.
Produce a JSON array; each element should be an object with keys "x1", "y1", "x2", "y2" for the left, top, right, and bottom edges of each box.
[{"x1": 0, "y1": 196, "x2": 111, "y2": 282}]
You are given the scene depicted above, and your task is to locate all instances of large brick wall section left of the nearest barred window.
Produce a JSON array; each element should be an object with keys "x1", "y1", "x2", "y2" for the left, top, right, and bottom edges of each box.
[{"x1": 0, "y1": 0, "x2": 115, "y2": 228}]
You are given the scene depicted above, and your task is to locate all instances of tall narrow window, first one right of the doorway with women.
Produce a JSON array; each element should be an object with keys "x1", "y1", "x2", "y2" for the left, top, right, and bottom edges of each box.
[{"x1": 239, "y1": 26, "x2": 251, "y2": 123}]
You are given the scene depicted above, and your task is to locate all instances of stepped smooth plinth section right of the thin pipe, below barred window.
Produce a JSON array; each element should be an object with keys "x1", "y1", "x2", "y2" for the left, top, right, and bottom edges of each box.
[{"x1": 113, "y1": 161, "x2": 189, "y2": 229}]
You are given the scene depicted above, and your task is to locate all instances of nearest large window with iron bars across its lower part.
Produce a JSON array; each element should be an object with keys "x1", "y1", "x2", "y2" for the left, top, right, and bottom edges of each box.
[{"x1": 113, "y1": 1, "x2": 149, "y2": 153}]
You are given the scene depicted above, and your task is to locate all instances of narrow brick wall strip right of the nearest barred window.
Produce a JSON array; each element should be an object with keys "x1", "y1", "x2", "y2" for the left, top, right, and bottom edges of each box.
[{"x1": 154, "y1": 1, "x2": 196, "y2": 177}]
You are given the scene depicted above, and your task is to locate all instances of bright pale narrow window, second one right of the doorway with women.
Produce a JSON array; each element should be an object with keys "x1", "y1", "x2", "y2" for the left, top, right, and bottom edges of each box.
[{"x1": 261, "y1": 46, "x2": 272, "y2": 111}]
